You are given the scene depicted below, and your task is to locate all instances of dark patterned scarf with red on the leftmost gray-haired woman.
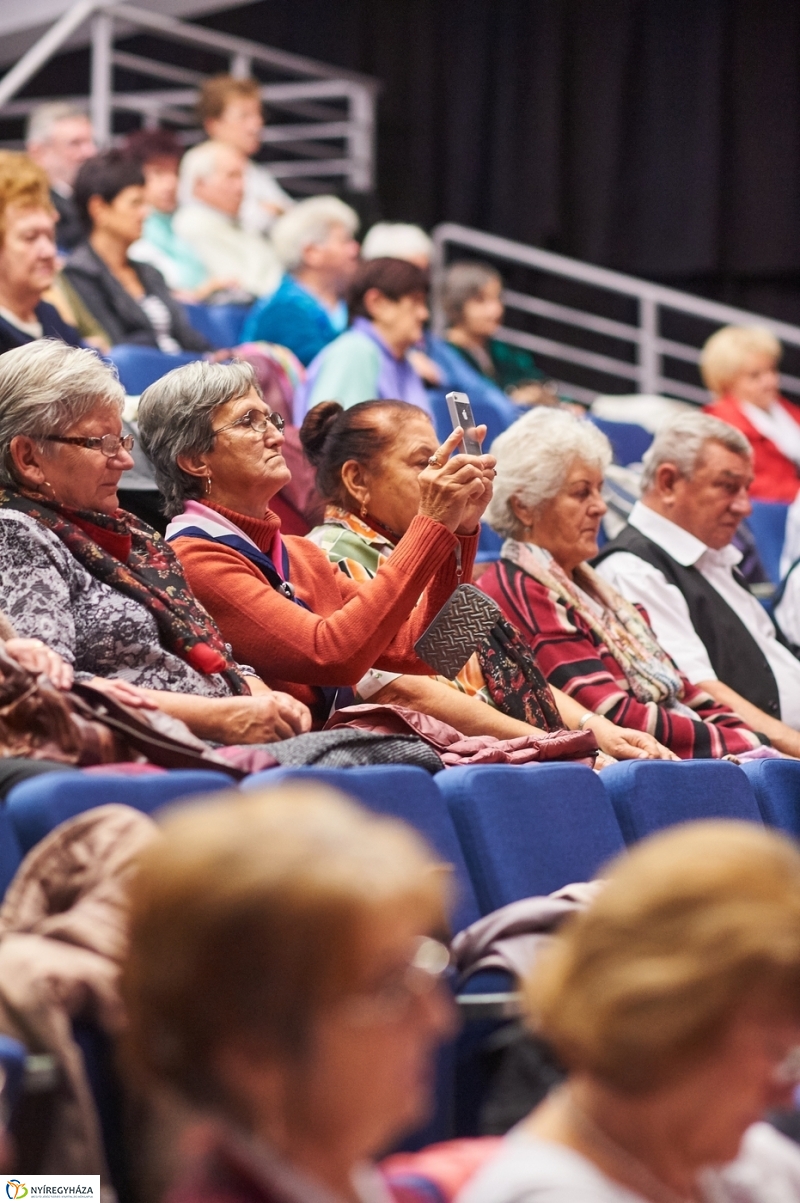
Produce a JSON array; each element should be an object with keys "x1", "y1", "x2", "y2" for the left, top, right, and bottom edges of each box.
[{"x1": 0, "y1": 488, "x2": 249, "y2": 694}]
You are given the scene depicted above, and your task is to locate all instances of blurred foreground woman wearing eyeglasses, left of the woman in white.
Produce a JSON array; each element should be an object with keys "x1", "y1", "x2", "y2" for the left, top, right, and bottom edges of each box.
[{"x1": 122, "y1": 784, "x2": 454, "y2": 1203}]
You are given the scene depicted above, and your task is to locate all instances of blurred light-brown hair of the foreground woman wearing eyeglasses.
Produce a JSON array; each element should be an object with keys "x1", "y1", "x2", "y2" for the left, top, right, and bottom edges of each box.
[{"x1": 122, "y1": 786, "x2": 445, "y2": 1104}]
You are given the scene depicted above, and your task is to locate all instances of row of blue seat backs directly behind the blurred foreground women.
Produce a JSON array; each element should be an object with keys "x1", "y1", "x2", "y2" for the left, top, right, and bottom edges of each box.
[{"x1": 7, "y1": 759, "x2": 800, "y2": 914}]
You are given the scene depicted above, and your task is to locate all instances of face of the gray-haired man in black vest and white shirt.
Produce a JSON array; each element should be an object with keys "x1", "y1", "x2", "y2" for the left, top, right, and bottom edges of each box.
[{"x1": 658, "y1": 439, "x2": 753, "y2": 550}]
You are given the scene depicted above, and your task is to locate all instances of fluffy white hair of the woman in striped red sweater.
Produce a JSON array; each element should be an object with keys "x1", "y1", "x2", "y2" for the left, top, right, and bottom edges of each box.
[{"x1": 485, "y1": 405, "x2": 611, "y2": 539}]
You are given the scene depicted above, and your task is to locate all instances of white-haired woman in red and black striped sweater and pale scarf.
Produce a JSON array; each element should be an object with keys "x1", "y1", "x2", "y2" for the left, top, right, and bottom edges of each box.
[{"x1": 480, "y1": 409, "x2": 762, "y2": 759}]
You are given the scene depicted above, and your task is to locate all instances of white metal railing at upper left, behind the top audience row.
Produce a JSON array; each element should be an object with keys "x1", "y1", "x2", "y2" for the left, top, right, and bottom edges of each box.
[{"x1": 0, "y1": 0, "x2": 379, "y2": 192}]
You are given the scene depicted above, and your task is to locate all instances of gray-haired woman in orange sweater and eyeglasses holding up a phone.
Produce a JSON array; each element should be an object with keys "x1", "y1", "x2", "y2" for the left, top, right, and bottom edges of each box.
[{"x1": 138, "y1": 363, "x2": 494, "y2": 725}]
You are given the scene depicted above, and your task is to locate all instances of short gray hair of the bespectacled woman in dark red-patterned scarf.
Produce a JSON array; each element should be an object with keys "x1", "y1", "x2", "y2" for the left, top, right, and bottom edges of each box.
[{"x1": 0, "y1": 338, "x2": 125, "y2": 486}]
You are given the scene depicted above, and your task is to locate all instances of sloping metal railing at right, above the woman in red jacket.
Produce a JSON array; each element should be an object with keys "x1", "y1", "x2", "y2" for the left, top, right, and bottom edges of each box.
[{"x1": 433, "y1": 221, "x2": 800, "y2": 404}]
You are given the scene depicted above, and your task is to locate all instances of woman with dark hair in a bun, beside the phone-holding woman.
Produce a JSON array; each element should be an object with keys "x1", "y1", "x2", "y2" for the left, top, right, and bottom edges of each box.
[{"x1": 301, "y1": 401, "x2": 671, "y2": 759}]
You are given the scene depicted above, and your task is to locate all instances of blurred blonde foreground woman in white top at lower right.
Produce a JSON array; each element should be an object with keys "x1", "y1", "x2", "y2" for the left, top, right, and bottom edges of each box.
[{"x1": 458, "y1": 822, "x2": 800, "y2": 1203}]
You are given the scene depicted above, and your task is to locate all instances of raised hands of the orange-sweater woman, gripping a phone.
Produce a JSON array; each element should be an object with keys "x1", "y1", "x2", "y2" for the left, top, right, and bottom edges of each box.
[{"x1": 419, "y1": 426, "x2": 494, "y2": 534}]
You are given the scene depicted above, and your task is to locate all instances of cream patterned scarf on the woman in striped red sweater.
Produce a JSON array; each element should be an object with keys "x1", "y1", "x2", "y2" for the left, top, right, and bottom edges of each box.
[{"x1": 500, "y1": 539, "x2": 683, "y2": 706}]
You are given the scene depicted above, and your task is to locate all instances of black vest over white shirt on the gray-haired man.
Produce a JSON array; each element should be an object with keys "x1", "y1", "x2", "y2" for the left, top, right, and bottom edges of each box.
[{"x1": 592, "y1": 526, "x2": 781, "y2": 718}]
